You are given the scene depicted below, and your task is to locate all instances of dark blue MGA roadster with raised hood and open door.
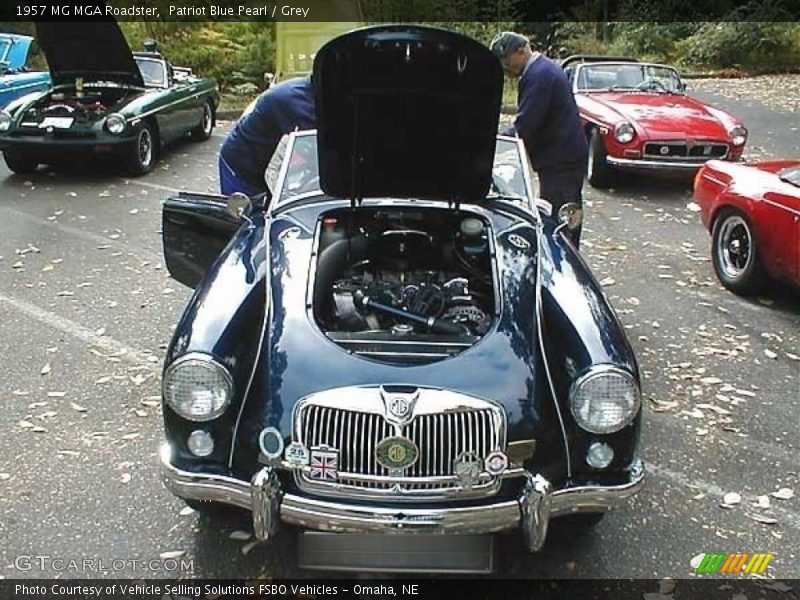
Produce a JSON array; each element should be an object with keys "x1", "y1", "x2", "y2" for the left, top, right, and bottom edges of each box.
[{"x1": 161, "y1": 25, "x2": 644, "y2": 572}]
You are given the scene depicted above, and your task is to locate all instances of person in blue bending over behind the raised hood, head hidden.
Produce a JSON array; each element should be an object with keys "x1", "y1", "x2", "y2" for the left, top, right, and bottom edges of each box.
[{"x1": 219, "y1": 77, "x2": 316, "y2": 196}]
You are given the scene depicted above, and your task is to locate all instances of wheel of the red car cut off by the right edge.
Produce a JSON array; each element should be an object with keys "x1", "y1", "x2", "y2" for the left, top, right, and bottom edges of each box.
[{"x1": 711, "y1": 209, "x2": 762, "y2": 296}]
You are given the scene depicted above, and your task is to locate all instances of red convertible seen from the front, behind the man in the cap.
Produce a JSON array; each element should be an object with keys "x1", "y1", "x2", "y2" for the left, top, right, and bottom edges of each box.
[{"x1": 562, "y1": 55, "x2": 747, "y2": 188}]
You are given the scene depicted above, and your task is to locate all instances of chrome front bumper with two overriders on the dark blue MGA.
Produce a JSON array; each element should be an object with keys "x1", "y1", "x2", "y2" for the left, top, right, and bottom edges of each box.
[{"x1": 161, "y1": 444, "x2": 644, "y2": 551}]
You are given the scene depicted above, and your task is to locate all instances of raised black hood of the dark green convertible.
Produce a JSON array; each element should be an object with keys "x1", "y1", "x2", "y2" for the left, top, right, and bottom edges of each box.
[{"x1": 36, "y1": 21, "x2": 144, "y2": 87}]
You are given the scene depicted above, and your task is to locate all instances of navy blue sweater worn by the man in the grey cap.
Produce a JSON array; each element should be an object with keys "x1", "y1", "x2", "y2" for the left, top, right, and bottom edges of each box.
[{"x1": 513, "y1": 56, "x2": 589, "y2": 171}]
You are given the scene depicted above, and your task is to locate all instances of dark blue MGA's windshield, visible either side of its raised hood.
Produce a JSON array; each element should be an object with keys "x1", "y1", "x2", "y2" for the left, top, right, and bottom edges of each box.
[{"x1": 276, "y1": 135, "x2": 527, "y2": 202}]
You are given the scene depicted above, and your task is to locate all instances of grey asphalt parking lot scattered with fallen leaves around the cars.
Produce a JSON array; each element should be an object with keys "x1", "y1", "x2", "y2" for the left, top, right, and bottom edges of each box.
[{"x1": 0, "y1": 85, "x2": 800, "y2": 578}]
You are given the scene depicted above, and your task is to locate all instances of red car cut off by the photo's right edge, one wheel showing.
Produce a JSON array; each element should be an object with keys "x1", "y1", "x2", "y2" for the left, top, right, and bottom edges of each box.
[{"x1": 694, "y1": 160, "x2": 800, "y2": 295}]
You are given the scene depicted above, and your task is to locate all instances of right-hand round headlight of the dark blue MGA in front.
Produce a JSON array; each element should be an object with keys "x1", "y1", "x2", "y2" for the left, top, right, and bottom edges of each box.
[{"x1": 569, "y1": 366, "x2": 641, "y2": 433}]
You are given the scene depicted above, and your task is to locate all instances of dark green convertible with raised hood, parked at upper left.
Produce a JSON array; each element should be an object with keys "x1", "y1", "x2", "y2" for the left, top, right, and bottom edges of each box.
[{"x1": 0, "y1": 21, "x2": 219, "y2": 175}]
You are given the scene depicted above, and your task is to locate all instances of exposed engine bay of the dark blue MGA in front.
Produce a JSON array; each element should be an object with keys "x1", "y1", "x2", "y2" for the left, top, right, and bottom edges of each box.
[{"x1": 314, "y1": 208, "x2": 495, "y2": 354}]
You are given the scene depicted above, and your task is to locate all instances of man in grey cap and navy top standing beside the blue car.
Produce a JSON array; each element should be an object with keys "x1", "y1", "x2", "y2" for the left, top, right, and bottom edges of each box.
[{"x1": 489, "y1": 31, "x2": 589, "y2": 246}]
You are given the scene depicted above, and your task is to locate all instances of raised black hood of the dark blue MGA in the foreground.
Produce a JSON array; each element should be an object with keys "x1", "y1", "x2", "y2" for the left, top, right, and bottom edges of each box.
[{"x1": 312, "y1": 25, "x2": 503, "y2": 203}]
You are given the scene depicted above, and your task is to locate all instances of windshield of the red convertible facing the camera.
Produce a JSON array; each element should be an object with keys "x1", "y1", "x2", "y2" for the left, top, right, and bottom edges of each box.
[{"x1": 578, "y1": 64, "x2": 683, "y2": 94}]
